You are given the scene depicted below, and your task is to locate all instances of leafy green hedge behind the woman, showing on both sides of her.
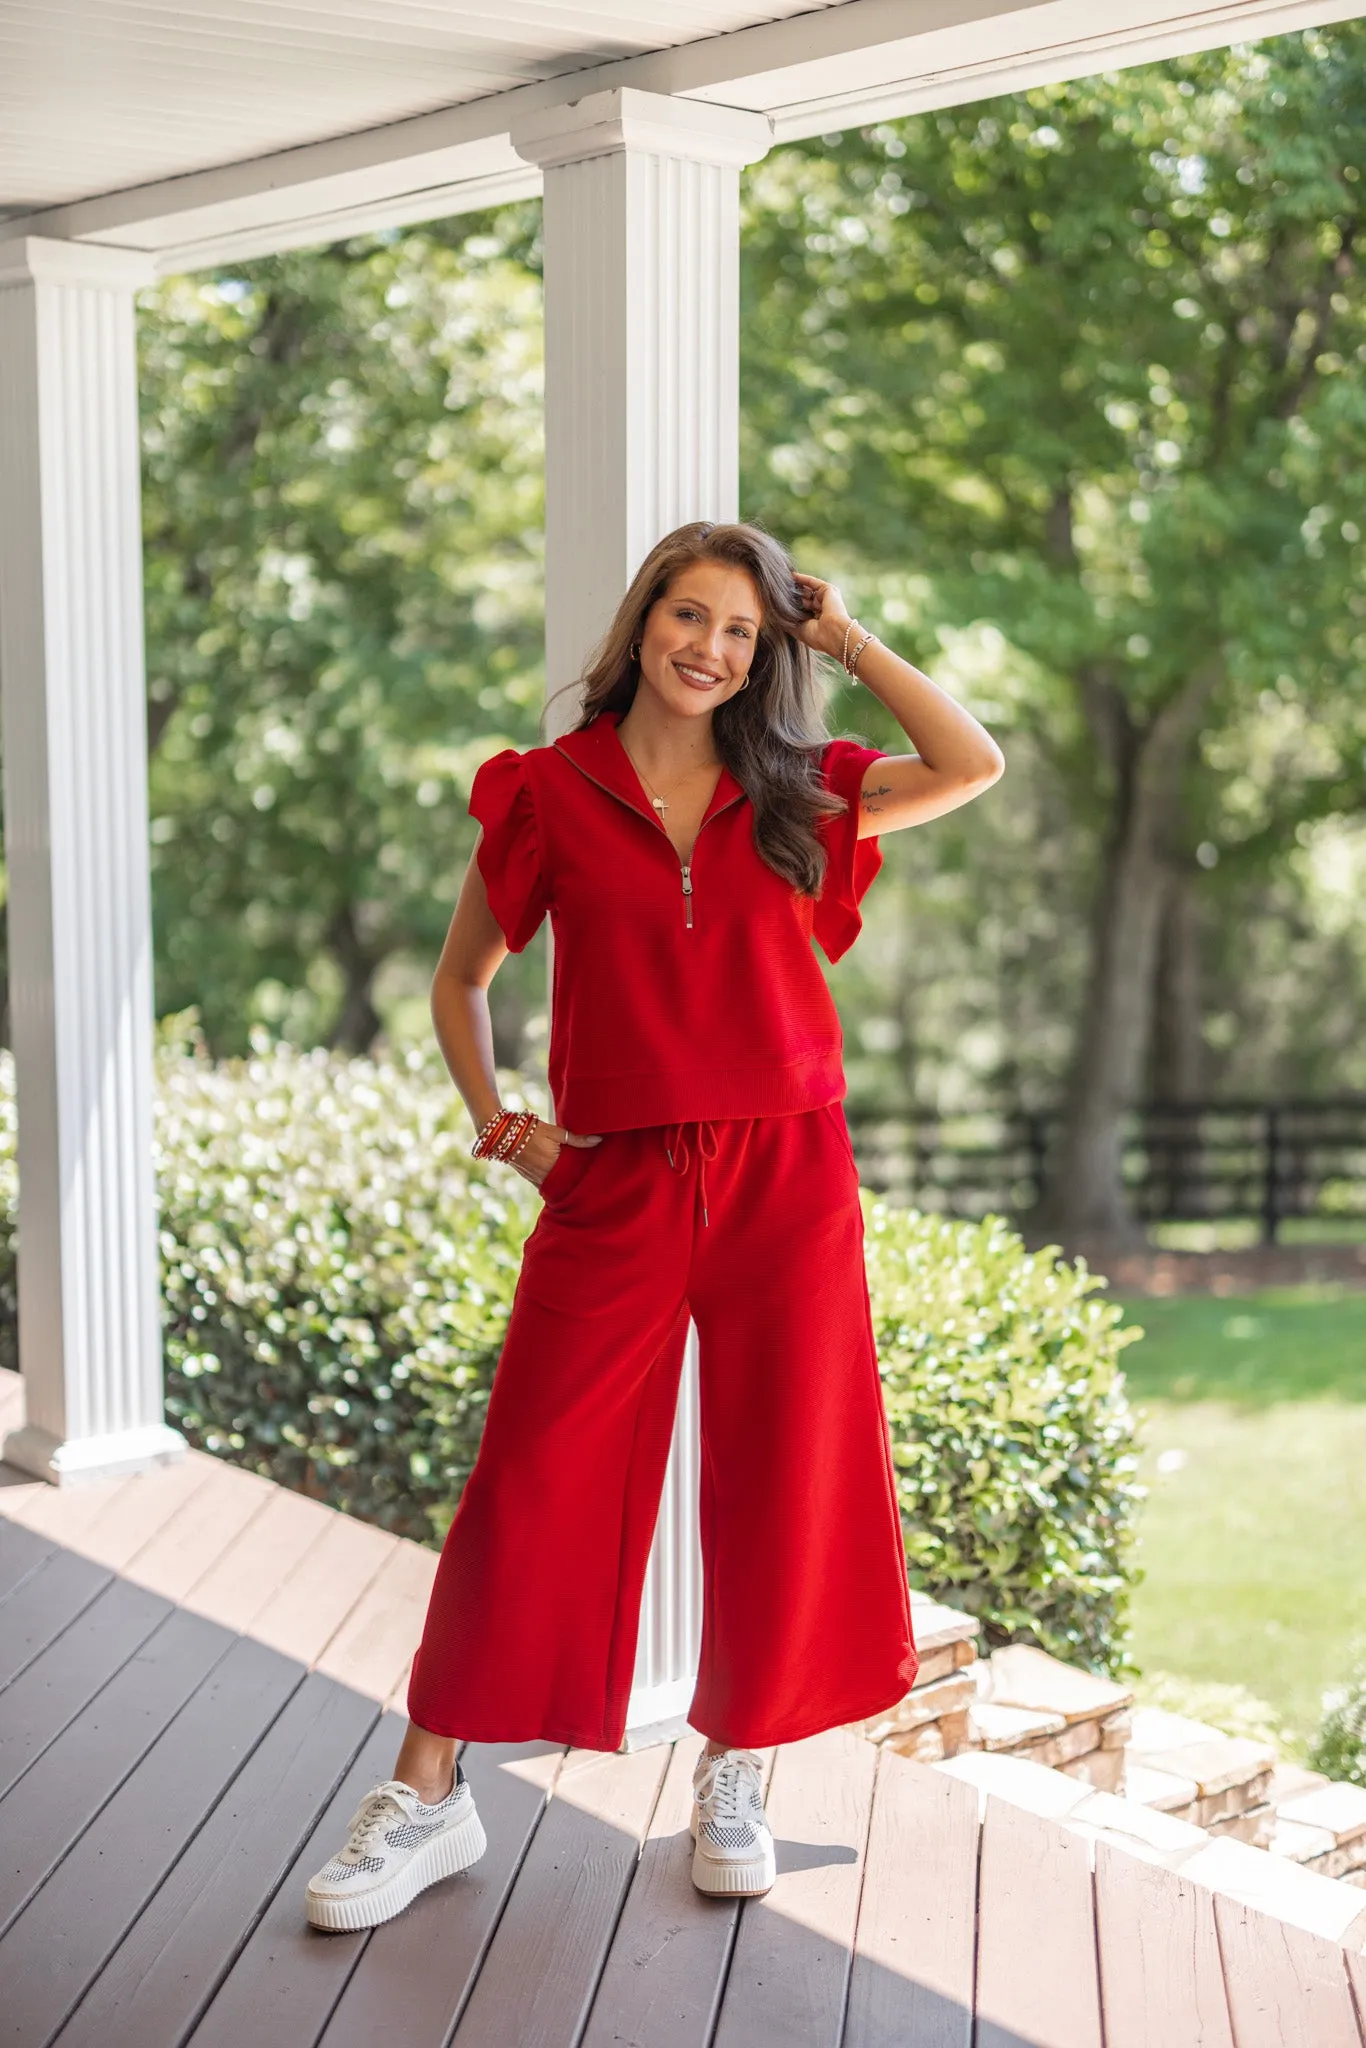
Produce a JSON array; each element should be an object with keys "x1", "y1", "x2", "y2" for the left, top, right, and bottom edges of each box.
[{"x1": 0, "y1": 1012, "x2": 1141, "y2": 1669}]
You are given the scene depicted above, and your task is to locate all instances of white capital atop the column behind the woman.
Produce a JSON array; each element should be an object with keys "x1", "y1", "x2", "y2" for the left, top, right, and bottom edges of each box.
[{"x1": 512, "y1": 86, "x2": 772, "y2": 170}]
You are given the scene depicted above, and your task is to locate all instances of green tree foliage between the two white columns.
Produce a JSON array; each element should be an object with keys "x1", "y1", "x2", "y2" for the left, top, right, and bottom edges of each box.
[{"x1": 139, "y1": 218, "x2": 543, "y2": 1059}]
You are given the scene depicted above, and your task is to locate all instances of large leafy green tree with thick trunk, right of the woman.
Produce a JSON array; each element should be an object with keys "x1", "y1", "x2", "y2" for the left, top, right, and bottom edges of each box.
[{"x1": 743, "y1": 25, "x2": 1366, "y2": 1239}]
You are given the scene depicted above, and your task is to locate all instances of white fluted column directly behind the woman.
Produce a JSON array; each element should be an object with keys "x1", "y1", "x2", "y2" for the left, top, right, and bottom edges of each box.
[{"x1": 512, "y1": 88, "x2": 772, "y2": 1747}]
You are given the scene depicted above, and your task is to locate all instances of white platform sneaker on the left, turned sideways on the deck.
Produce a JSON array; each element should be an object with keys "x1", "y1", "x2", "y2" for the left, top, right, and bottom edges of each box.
[{"x1": 303, "y1": 1769, "x2": 487, "y2": 1931}]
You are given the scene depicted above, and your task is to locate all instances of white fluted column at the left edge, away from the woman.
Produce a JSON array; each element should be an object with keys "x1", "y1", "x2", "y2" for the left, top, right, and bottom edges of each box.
[{"x1": 0, "y1": 238, "x2": 184, "y2": 1483}]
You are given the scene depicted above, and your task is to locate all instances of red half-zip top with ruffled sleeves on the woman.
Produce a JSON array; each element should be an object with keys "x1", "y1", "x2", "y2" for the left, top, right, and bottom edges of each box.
[{"x1": 469, "y1": 713, "x2": 885, "y2": 1133}]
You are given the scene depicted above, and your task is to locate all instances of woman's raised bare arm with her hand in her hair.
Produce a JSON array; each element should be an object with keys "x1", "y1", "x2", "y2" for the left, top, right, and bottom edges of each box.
[{"x1": 797, "y1": 575, "x2": 1006, "y2": 840}]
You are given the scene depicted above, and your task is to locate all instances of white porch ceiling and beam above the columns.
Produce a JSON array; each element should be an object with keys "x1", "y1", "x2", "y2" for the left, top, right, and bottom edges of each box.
[{"x1": 0, "y1": 0, "x2": 1362, "y2": 270}]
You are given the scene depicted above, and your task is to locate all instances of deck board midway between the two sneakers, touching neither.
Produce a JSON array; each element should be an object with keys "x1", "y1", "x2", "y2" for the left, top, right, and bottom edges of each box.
[{"x1": 453, "y1": 1747, "x2": 670, "y2": 2048}]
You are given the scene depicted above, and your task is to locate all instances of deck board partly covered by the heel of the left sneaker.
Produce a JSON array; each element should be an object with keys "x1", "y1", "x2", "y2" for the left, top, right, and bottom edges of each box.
[{"x1": 322, "y1": 1743, "x2": 563, "y2": 2048}]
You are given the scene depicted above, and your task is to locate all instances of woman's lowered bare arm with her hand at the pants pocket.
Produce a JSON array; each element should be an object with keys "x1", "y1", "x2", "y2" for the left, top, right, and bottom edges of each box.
[{"x1": 432, "y1": 831, "x2": 565, "y2": 1188}]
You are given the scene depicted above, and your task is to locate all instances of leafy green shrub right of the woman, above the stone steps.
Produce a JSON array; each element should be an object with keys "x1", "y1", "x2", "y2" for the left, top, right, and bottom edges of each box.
[{"x1": 864, "y1": 1196, "x2": 1145, "y2": 1671}]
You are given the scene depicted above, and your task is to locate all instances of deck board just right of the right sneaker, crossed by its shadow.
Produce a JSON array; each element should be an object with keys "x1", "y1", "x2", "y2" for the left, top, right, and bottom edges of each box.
[{"x1": 715, "y1": 1729, "x2": 877, "y2": 2048}]
